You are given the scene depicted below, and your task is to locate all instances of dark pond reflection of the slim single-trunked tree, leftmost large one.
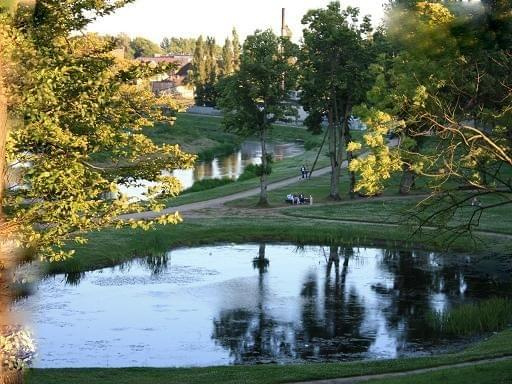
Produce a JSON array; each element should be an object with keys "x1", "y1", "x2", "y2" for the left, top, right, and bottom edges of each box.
[{"x1": 212, "y1": 244, "x2": 293, "y2": 364}]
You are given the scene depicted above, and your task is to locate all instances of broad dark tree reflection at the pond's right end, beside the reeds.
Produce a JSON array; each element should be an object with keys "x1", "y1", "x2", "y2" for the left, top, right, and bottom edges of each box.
[{"x1": 372, "y1": 250, "x2": 510, "y2": 342}]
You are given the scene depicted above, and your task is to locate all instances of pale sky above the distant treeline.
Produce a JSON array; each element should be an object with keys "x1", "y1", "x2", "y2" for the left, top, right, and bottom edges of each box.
[{"x1": 88, "y1": 0, "x2": 387, "y2": 45}]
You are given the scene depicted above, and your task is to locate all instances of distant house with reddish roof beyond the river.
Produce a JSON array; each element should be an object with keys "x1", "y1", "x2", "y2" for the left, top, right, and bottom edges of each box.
[{"x1": 137, "y1": 55, "x2": 194, "y2": 98}]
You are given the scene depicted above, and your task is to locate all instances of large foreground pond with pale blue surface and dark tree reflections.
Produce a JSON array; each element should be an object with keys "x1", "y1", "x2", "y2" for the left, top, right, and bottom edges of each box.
[{"x1": 17, "y1": 244, "x2": 512, "y2": 368}]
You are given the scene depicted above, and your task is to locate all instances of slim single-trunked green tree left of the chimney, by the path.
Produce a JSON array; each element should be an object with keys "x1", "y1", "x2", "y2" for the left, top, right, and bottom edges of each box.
[{"x1": 218, "y1": 30, "x2": 295, "y2": 206}]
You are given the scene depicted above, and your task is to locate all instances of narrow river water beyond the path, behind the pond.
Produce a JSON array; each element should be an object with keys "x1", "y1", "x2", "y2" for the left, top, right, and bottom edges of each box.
[{"x1": 119, "y1": 141, "x2": 304, "y2": 199}]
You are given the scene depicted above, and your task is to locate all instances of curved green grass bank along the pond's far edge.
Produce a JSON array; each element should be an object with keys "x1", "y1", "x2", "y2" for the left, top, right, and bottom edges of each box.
[{"x1": 48, "y1": 216, "x2": 510, "y2": 273}]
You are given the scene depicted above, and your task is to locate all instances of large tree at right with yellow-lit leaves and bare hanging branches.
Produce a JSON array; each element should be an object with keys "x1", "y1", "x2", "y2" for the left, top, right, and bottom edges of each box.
[{"x1": 351, "y1": 2, "x2": 512, "y2": 239}]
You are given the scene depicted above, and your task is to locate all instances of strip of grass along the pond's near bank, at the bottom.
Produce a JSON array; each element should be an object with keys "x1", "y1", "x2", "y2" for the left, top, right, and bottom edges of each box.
[{"x1": 26, "y1": 330, "x2": 512, "y2": 384}]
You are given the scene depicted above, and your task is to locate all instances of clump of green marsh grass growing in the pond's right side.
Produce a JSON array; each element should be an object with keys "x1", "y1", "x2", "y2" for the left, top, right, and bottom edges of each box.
[{"x1": 427, "y1": 298, "x2": 512, "y2": 336}]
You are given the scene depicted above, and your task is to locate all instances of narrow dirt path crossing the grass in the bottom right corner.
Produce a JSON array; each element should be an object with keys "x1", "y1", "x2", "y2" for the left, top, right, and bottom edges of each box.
[{"x1": 291, "y1": 356, "x2": 512, "y2": 384}]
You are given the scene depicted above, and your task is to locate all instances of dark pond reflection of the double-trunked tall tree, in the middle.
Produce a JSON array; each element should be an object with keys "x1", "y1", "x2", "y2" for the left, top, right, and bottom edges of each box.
[{"x1": 296, "y1": 246, "x2": 371, "y2": 360}]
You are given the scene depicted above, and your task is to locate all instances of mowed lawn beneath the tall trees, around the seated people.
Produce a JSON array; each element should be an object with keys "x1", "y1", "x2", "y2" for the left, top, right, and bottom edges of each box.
[{"x1": 226, "y1": 170, "x2": 512, "y2": 234}]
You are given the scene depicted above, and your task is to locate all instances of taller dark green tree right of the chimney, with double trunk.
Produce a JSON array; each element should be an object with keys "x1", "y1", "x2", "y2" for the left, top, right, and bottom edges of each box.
[{"x1": 299, "y1": 2, "x2": 372, "y2": 200}]
